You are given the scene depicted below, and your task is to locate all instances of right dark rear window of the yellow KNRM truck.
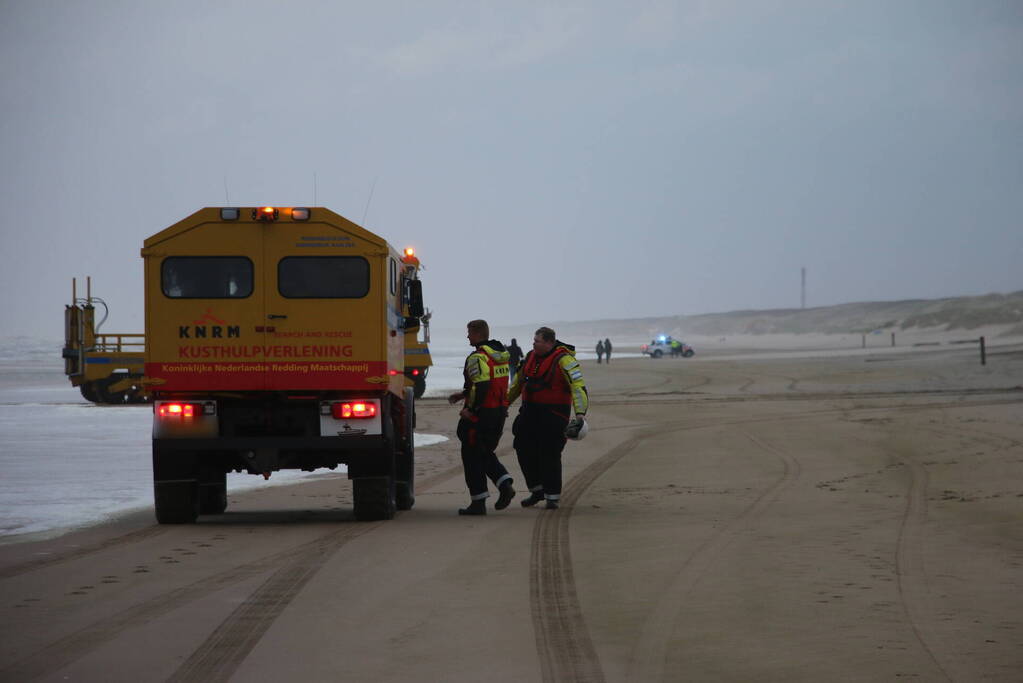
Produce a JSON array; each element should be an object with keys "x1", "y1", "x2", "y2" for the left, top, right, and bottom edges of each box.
[{"x1": 277, "y1": 257, "x2": 369, "y2": 299}]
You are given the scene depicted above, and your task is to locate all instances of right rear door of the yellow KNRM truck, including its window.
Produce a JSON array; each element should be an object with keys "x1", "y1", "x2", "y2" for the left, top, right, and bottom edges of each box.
[{"x1": 262, "y1": 221, "x2": 387, "y2": 391}]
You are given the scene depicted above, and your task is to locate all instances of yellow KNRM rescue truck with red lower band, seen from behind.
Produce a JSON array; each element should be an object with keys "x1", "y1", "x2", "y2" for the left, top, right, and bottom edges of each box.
[{"x1": 142, "y1": 207, "x2": 425, "y2": 523}]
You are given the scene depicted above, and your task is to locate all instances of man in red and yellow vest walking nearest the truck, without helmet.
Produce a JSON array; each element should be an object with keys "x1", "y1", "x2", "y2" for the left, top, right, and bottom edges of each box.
[{"x1": 448, "y1": 320, "x2": 515, "y2": 514}]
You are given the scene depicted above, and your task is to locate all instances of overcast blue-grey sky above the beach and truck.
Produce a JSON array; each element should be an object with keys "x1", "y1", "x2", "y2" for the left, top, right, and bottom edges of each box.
[{"x1": 0, "y1": 0, "x2": 1023, "y2": 339}]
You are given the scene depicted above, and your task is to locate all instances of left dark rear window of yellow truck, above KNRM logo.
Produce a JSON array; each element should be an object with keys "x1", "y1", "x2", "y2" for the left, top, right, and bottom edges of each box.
[{"x1": 160, "y1": 257, "x2": 253, "y2": 299}]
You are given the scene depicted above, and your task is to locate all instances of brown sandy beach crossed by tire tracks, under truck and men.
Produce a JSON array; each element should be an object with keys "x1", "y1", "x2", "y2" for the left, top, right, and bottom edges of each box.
[{"x1": 0, "y1": 340, "x2": 1023, "y2": 683}]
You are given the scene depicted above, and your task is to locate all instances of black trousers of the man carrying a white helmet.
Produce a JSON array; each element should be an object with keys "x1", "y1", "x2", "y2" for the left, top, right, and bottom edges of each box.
[{"x1": 512, "y1": 403, "x2": 571, "y2": 499}]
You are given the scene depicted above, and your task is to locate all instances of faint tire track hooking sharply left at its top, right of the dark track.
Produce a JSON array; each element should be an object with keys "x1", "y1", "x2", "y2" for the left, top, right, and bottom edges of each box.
[{"x1": 626, "y1": 432, "x2": 802, "y2": 683}]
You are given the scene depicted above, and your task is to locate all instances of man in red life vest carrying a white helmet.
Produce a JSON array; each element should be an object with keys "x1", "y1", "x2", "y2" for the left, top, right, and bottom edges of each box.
[{"x1": 508, "y1": 327, "x2": 589, "y2": 510}]
